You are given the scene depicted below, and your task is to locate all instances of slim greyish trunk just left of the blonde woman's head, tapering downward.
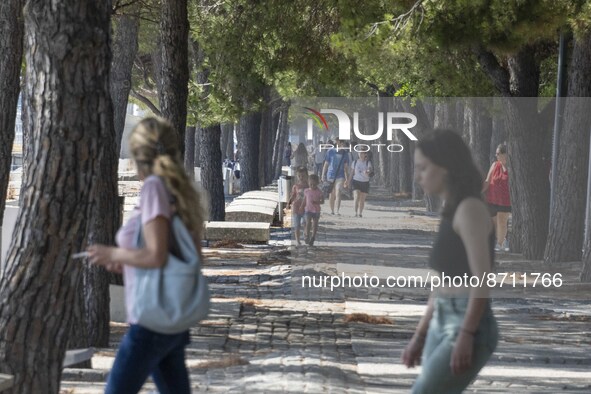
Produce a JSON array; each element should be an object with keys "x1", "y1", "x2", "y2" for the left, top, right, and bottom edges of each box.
[{"x1": 111, "y1": 10, "x2": 139, "y2": 156}]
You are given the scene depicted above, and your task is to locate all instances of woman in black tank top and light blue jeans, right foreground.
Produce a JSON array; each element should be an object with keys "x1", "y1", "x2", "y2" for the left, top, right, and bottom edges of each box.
[{"x1": 402, "y1": 130, "x2": 498, "y2": 394}]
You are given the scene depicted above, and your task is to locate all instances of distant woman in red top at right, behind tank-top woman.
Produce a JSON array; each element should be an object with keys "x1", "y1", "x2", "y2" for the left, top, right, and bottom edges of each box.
[{"x1": 483, "y1": 144, "x2": 511, "y2": 252}]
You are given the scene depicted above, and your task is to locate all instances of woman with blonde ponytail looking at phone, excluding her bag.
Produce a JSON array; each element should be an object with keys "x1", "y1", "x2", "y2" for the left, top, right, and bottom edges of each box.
[{"x1": 88, "y1": 118, "x2": 203, "y2": 394}]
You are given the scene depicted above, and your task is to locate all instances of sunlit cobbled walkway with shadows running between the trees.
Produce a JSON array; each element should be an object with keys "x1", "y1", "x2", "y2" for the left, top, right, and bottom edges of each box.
[{"x1": 62, "y1": 189, "x2": 591, "y2": 393}]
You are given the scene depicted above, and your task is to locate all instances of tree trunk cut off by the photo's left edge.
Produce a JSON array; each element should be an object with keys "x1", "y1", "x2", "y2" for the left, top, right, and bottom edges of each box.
[{"x1": 0, "y1": 0, "x2": 24, "y2": 234}]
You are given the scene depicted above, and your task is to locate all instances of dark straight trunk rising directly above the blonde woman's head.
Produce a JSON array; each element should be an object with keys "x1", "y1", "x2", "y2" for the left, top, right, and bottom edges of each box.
[{"x1": 159, "y1": 0, "x2": 189, "y2": 154}]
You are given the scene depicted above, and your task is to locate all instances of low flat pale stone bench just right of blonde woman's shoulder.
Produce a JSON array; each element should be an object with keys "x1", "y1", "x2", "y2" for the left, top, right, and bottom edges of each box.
[{"x1": 205, "y1": 222, "x2": 271, "y2": 242}]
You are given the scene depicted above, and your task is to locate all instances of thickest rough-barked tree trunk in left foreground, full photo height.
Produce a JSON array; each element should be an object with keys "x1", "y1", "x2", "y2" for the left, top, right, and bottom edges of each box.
[{"x1": 0, "y1": 0, "x2": 114, "y2": 393}]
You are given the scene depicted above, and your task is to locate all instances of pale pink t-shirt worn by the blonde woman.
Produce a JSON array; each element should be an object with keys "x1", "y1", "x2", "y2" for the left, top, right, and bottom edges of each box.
[{"x1": 115, "y1": 175, "x2": 172, "y2": 324}]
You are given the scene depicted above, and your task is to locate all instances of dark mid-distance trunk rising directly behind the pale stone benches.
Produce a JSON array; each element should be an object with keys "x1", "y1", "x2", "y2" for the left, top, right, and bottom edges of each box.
[{"x1": 238, "y1": 110, "x2": 261, "y2": 193}]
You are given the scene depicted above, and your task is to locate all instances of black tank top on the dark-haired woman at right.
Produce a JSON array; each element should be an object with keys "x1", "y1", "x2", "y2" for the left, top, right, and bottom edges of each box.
[{"x1": 429, "y1": 218, "x2": 495, "y2": 276}]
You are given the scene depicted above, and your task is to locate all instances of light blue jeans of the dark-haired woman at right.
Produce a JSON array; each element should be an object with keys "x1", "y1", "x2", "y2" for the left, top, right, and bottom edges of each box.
[{"x1": 412, "y1": 297, "x2": 498, "y2": 394}]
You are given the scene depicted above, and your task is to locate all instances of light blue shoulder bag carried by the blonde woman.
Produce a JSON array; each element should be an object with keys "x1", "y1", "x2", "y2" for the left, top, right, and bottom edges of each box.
[{"x1": 132, "y1": 215, "x2": 210, "y2": 334}]
